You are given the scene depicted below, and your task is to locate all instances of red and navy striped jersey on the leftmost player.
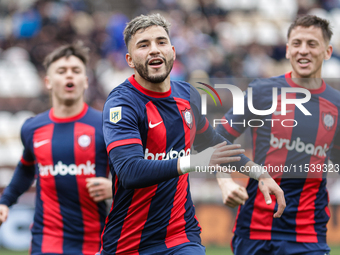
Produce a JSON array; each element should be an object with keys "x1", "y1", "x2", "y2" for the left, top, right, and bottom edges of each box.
[{"x1": 0, "y1": 104, "x2": 109, "y2": 254}]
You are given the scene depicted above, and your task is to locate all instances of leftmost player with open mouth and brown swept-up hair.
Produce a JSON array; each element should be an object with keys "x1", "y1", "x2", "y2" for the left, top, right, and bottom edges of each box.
[{"x1": 0, "y1": 43, "x2": 112, "y2": 255}]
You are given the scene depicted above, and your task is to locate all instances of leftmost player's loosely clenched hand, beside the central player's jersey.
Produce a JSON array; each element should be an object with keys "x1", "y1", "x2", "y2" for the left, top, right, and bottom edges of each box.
[{"x1": 86, "y1": 177, "x2": 112, "y2": 202}]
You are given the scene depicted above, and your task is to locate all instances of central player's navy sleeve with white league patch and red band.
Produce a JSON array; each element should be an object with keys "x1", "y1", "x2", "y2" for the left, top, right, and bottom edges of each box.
[{"x1": 103, "y1": 91, "x2": 178, "y2": 189}]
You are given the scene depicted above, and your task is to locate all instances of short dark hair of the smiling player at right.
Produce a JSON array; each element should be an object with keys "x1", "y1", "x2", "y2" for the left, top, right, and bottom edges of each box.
[{"x1": 287, "y1": 15, "x2": 333, "y2": 42}]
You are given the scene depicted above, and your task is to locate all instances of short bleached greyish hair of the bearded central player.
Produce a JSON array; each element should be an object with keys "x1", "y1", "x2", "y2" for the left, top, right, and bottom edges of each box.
[{"x1": 123, "y1": 13, "x2": 170, "y2": 47}]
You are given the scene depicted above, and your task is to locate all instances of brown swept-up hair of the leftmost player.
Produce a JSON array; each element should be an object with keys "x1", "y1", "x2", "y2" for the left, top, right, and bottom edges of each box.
[{"x1": 43, "y1": 41, "x2": 90, "y2": 70}]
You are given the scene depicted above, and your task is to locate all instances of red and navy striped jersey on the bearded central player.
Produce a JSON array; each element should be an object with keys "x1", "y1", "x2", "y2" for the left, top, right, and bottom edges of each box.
[{"x1": 101, "y1": 76, "x2": 249, "y2": 255}]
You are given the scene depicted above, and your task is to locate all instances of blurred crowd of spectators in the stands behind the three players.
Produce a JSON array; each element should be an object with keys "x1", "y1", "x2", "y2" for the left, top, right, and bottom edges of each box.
[{"x1": 0, "y1": 0, "x2": 340, "y2": 113}]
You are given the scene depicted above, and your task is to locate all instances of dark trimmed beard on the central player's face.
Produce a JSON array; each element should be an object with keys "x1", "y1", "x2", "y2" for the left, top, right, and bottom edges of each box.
[{"x1": 133, "y1": 57, "x2": 174, "y2": 83}]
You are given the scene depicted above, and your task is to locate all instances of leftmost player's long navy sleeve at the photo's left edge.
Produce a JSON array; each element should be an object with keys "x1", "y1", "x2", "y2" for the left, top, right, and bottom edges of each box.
[{"x1": 0, "y1": 120, "x2": 35, "y2": 206}]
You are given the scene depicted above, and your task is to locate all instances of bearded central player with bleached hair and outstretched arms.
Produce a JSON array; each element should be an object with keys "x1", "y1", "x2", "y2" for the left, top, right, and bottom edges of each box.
[{"x1": 100, "y1": 14, "x2": 285, "y2": 255}]
